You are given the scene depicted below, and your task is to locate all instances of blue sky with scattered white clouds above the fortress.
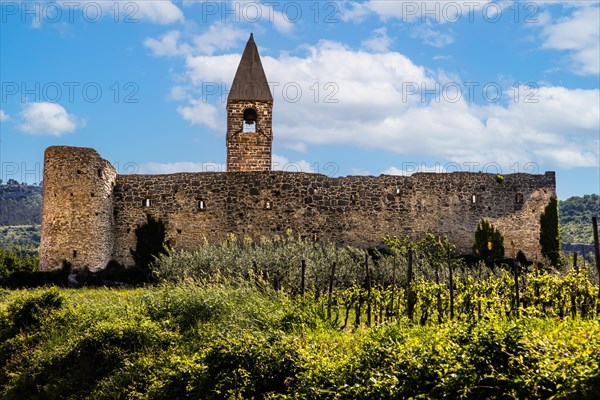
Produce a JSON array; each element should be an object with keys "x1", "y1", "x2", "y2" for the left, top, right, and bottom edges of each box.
[{"x1": 0, "y1": 0, "x2": 600, "y2": 199}]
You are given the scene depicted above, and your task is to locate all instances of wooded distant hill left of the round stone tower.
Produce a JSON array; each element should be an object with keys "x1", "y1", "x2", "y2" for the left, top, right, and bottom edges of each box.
[{"x1": 0, "y1": 182, "x2": 42, "y2": 226}]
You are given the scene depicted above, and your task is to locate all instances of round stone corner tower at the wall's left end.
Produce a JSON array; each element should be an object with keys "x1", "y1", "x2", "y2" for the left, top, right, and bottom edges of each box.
[{"x1": 40, "y1": 146, "x2": 117, "y2": 271}]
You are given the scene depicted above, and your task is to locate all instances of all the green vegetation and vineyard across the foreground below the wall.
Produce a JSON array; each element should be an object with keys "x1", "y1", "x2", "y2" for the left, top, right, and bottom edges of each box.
[{"x1": 0, "y1": 234, "x2": 600, "y2": 400}]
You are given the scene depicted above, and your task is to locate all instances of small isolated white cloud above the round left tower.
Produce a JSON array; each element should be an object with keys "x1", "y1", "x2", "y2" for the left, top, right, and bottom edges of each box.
[{"x1": 17, "y1": 102, "x2": 86, "y2": 136}]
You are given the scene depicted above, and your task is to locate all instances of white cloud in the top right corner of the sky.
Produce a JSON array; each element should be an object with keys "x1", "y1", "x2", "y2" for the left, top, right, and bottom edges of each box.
[{"x1": 542, "y1": 4, "x2": 600, "y2": 75}]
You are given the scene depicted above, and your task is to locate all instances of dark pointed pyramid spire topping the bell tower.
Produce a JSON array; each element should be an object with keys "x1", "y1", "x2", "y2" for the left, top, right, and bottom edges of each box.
[{"x1": 227, "y1": 33, "x2": 273, "y2": 101}]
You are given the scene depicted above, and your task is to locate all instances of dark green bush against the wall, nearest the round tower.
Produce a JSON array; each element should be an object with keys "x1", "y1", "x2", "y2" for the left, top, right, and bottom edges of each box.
[{"x1": 131, "y1": 214, "x2": 166, "y2": 276}]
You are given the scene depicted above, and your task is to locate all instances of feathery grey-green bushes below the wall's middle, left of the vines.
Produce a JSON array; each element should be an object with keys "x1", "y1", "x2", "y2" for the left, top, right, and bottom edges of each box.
[{"x1": 153, "y1": 232, "x2": 366, "y2": 293}]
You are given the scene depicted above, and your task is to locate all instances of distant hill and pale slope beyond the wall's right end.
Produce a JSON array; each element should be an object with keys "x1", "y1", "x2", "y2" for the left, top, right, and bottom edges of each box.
[{"x1": 558, "y1": 194, "x2": 600, "y2": 245}]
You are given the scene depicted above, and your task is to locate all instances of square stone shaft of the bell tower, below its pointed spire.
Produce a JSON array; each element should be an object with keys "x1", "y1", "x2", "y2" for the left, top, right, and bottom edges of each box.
[{"x1": 227, "y1": 100, "x2": 273, "y2": 172}]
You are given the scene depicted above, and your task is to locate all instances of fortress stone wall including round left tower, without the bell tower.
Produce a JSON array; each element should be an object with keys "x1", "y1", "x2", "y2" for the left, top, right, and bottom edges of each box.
[{"x1": 41, "y1": 147, "x2": 555, "y2": 269}]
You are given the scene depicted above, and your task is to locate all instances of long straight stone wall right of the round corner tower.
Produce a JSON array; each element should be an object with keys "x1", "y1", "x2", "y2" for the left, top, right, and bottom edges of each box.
[{"x1": 113, "y1": 172, "x2": 555, "y2": 264}]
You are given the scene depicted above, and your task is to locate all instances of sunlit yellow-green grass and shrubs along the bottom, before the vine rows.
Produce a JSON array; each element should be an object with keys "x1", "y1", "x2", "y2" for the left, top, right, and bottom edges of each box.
[{"x1": 0, "y1": 284, "x2": 600, "y2": 400}]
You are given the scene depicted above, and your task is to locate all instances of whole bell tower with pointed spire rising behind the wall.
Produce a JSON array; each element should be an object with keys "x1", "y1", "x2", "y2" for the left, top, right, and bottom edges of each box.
[{"x1": 227, "y1": 34, "x2": 273, "y2": 172}]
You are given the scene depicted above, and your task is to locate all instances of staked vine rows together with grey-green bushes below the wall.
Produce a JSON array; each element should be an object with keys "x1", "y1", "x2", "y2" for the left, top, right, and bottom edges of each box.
[{"x1": 154, "y1": 234, "x2": 600, "y2": 328}]
